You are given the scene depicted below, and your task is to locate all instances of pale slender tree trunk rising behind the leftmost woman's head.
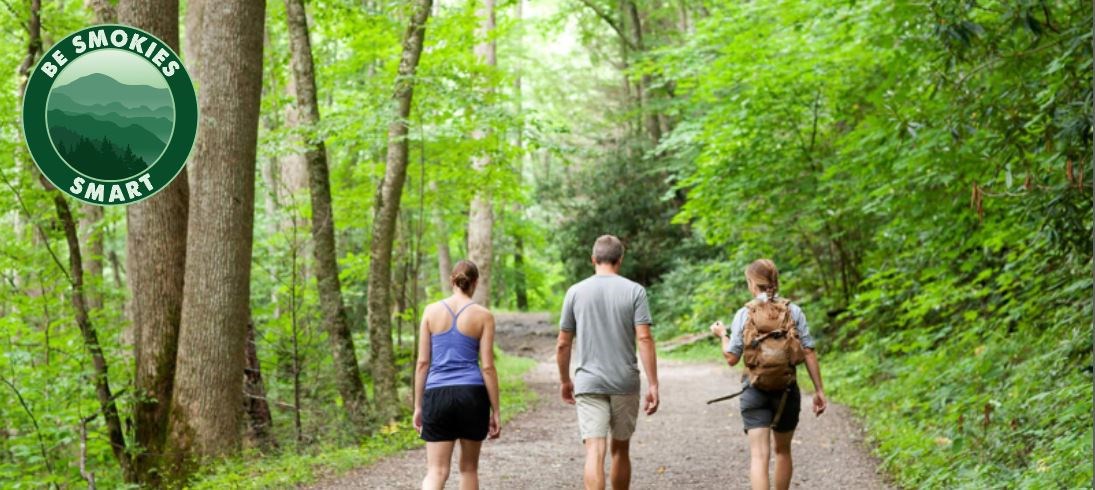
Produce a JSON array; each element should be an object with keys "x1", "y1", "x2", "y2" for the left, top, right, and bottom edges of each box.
[{"x1": 468, "y1": 0, "x2": 498, "y2": 306}]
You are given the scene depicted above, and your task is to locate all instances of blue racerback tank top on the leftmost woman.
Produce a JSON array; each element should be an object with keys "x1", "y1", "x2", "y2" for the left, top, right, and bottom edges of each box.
[{"x1": 426, "y1": 301, "x2": 484, "y2": 389}]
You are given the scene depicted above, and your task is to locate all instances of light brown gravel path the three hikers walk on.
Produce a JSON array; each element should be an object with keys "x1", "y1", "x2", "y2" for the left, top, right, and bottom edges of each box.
[{"x1": 313, "y1": 315, "x2": 887, "y2": 489}]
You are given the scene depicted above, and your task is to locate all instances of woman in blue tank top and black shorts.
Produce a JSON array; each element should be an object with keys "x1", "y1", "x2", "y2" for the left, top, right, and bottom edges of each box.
[{"x1": 414, "y1": 260, "x2": 502, "y2": 489}]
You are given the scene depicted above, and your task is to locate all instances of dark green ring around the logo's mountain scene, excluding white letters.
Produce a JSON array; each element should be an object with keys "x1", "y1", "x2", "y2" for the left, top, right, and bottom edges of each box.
[{"x1": 22, "y1": 24, "x2": 198, "y2": 206}]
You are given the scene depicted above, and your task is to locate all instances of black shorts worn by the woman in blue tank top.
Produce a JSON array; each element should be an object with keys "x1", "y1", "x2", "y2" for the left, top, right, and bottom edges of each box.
[{"x1": 422, "y1": 385, "x2": 491, "y2": 443}]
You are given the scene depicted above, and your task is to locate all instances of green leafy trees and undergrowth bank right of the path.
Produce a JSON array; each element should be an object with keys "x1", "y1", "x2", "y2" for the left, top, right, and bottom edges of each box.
[{"x1": 658, "y1": 1, "x2": 1092, "y2": 488}]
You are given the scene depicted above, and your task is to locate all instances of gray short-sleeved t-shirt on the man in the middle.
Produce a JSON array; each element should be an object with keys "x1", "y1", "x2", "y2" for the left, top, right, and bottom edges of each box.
[{"x1": 560, "y1": 274, "x2": 652, "y2": 395}]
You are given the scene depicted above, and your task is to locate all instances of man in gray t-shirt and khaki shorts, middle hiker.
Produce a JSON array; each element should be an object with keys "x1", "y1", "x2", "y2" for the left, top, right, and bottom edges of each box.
[{"x1": 555, "y1": 235, "x2": 659, "y2": 489}]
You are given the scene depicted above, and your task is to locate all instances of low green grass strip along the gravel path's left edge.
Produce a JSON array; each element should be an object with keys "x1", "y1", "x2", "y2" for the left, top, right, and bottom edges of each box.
[{"x1": 186, "y1": 353, "x2": 537, "y2": 490}]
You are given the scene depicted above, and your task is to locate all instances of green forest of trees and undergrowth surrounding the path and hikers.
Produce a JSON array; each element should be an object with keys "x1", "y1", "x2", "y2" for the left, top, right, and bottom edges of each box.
[{"x1": 0, "y1": 0, "x2": 1095, "y2": 489}]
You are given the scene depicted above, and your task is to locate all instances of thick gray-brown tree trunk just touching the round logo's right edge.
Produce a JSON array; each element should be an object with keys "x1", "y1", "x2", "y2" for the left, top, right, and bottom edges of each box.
[{"x1": 168, "y1": 0, "x2": 265, "y2": 474}]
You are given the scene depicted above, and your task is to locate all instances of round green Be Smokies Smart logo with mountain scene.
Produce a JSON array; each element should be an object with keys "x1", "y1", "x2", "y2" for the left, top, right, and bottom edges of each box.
[{"x1": 23, "y1": 24, "x2": 198, "y2": 206}]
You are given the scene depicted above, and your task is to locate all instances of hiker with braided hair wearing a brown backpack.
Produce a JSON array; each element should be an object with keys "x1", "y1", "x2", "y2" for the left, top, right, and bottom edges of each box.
[{"x1": 711, "y1": 259, "x2": 828, "y2": 490}]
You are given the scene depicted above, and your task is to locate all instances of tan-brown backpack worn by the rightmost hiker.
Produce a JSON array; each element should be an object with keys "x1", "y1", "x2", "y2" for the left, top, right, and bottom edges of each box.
[{"x1": 741, "y1": 297, "x2": 806, "y2": 390}]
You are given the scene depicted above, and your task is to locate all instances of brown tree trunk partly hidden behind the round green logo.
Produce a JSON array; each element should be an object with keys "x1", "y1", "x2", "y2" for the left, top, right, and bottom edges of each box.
[{"x1": 118, "y1": 0, "x2": 194, "y2": 486}]
